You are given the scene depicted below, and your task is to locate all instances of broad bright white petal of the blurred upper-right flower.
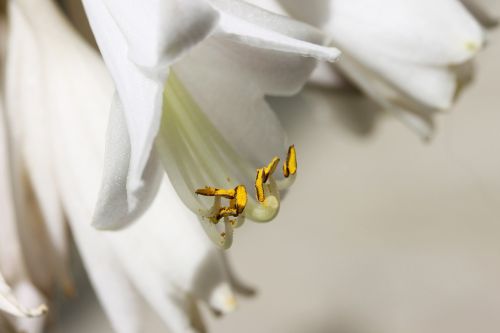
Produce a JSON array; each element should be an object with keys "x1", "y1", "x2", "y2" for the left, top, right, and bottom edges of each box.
[{"x1": 325, "y1": 0, "x2": 484, "y2": 108}]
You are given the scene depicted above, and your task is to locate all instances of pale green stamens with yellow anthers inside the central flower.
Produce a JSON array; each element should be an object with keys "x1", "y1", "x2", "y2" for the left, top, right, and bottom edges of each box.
[{"x1": 156, "y1": 72, "x2": 297, "y2": 248}]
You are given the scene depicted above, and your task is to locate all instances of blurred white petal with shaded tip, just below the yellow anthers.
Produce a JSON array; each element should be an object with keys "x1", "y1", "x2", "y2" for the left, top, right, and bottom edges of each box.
[{"x1": 109, "y1": 179, "x2": 235, "y2": 332}]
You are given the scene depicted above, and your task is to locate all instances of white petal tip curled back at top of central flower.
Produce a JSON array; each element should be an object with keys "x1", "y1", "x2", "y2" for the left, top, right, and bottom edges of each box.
[{"x1": 100, "y1": 0, "x2": 218, "y2": 69}]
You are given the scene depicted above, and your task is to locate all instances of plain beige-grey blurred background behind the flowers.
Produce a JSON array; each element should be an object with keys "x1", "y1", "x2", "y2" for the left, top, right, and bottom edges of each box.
[{"x1": 54, "y1": 2, "x2": 500, "y2": 333}]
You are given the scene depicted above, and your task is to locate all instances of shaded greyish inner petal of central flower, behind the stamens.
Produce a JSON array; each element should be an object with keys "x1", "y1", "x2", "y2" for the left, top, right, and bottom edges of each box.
[{"x1": 174, "y1": 39, "x2": 288, "y2": 165}]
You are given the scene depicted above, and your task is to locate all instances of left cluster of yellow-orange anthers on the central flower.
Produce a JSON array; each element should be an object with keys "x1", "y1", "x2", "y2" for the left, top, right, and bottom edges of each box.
[{"x1": 195, "y1": 185, "x2": 248, "y2": 224}]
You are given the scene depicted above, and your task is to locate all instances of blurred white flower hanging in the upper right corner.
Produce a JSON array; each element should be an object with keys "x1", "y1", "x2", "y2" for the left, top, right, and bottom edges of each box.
[{"x1": 279, "y1": 0, "x2": 484, "y2": 138}]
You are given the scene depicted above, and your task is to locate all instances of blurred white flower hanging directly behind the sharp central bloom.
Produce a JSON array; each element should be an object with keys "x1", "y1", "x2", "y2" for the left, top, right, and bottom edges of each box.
[{"x1": 7, "y1": 0, "x2": 256, "y2": 333}]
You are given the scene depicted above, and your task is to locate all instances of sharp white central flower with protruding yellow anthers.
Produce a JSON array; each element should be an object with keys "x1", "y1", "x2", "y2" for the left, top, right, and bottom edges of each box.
[{"x1": 83, "y1": 0, "x2": 339, "y2": 247}]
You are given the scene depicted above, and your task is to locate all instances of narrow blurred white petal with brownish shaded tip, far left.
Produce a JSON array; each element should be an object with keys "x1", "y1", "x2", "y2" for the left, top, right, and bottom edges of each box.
[{"x1": 6, "y1": 0, "x2": 72, "y2": 292}]
